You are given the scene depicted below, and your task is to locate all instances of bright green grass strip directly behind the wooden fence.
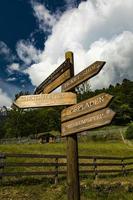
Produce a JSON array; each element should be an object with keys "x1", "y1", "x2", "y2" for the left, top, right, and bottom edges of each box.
[{"x1": 0, "y1": 141, "x2": 133, "y2": 156}]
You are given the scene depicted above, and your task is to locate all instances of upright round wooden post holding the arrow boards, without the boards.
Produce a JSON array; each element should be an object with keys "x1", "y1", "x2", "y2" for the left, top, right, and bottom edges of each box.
[{"x1": 65, "y1": 52, "x2": 80, "y2": 200}]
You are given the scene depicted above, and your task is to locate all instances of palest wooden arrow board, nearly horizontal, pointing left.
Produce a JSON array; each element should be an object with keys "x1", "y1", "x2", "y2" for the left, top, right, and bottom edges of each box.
[{"x1": 13, "y1": 92, "x2": 77, "y2": 108}]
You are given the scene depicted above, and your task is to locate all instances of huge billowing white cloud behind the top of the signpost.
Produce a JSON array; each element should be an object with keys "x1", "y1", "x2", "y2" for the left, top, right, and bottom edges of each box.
[{"x1": 23, "y1": 0, "x2": 133, "y2": 87}]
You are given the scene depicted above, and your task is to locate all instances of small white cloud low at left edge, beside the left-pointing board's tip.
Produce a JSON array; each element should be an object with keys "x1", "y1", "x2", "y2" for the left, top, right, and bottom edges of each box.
[{"x1": 0, "y1": 88, "x2": 12, "y2": 107}]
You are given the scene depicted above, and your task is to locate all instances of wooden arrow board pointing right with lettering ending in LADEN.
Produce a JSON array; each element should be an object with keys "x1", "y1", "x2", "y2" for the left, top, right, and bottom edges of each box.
[{"x1": 61, "y1": 93, "x2": 113, "y2": 122}]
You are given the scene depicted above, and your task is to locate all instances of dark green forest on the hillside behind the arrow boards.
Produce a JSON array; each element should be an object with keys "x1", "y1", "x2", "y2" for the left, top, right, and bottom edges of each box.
[{"x1": 0, "y1": 79, "x2": 133, "y2": 138}]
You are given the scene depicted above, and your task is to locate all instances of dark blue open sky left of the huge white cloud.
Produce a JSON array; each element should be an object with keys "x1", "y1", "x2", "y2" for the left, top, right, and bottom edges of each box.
[{"x1": 0, "y1": 0, "x2": 83, "y2": 106}]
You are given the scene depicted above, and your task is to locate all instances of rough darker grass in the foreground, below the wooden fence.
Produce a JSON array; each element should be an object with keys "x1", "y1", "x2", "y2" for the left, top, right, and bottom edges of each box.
[{"x1": 0, "y1": 176, "x2": 133, "y2": 200}]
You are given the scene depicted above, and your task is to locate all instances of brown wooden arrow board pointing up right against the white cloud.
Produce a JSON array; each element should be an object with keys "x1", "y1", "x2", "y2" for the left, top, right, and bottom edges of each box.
[{"x1": 62, "y1": 61, "x2": 105, "y2": 92}]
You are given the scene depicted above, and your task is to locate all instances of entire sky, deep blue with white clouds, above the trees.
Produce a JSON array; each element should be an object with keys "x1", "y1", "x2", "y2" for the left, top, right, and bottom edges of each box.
[{"x1": 0, "y1": 0, "x2": 133, "y2": 106}]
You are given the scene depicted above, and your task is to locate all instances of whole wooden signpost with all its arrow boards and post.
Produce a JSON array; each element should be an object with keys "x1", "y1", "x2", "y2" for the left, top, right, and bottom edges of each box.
[{"x1": 13, "y1": 52, "x2": 115, "y2": 200}]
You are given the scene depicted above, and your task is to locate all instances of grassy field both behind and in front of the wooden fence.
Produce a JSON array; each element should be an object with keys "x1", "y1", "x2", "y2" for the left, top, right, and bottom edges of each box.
[{"x1": 0, "y1": 141, "x2": 133, "y2": 200}]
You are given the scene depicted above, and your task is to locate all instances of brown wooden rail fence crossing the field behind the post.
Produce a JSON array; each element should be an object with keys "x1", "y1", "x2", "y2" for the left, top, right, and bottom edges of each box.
[{"x1": 0, "y1": 153, "x2": 133, "y2": 183}]
